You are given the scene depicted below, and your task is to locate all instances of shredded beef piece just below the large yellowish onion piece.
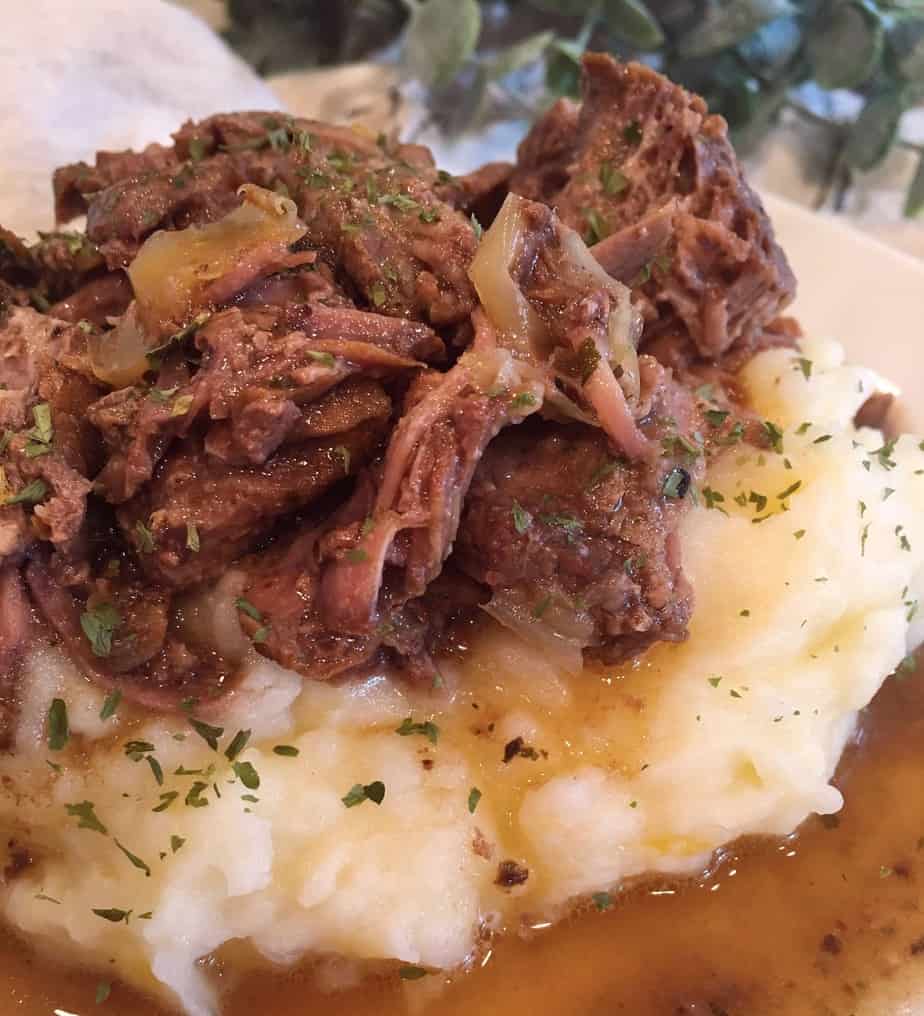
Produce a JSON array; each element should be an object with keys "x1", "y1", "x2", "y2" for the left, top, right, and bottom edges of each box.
[{"x1": 89, "y1": 304, "x2": 443, "y2": 504}]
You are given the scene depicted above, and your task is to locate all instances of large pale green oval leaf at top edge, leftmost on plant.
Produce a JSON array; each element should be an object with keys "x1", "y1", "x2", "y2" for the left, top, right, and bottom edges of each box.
[{"x1": 405, "y1": 0, "x2": 481, "y2": 87}]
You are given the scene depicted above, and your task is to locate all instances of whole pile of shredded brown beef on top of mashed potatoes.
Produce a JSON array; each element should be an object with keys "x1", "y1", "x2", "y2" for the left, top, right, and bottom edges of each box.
[{"x1": 0, "y1": 55, "x2": 801, "y2": 707}]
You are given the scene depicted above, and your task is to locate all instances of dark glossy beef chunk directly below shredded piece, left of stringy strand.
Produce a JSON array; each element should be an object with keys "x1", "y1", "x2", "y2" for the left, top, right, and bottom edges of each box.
[{"x1": 118, "y1": 412, "x2": 389, "y2": 587}]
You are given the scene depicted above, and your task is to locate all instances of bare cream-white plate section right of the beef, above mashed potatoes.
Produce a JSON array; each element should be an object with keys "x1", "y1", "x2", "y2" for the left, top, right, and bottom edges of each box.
[{"x1": 763, "y1": 195, "x2": 924, "y2": 432}]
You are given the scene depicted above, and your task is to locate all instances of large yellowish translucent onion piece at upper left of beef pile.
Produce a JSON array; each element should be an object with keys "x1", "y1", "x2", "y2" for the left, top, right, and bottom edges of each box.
[{"x1": 128, "y1": 184, "x2": 307, "y2": 335}]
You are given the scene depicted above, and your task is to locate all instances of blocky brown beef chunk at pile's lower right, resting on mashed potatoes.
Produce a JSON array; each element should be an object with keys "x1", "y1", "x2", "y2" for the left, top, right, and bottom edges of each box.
[{"x1": 452, "y1": 358, "x2": 709, "y2": 661}]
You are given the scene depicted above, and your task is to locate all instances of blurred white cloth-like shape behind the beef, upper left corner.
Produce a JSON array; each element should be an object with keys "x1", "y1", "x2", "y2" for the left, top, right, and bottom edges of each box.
[{"x1": 0, "y1": 0, "x2": 280, "y2": 236}]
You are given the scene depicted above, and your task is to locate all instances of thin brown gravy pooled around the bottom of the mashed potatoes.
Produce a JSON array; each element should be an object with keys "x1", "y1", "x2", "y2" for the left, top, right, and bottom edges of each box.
[{"x1": 0, "y1": 663, "x2": 924, "y2": 1016}]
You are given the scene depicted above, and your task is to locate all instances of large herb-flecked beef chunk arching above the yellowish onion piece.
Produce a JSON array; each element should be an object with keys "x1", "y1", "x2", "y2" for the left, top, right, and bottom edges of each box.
[{"x1": 59, "y1": 113, "x2": 476, "y2": 325}]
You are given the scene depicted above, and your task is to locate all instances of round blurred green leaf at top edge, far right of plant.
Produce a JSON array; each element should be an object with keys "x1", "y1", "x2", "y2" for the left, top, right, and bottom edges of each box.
[{"x1": 805, "y1": 3, "x2": 885, "y2": 88}]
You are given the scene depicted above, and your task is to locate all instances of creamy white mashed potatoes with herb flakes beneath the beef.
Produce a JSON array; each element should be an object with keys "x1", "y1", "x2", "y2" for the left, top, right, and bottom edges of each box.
[{"x1": 0, "y1": 342, "x2": 924, "y2": 1016}]
